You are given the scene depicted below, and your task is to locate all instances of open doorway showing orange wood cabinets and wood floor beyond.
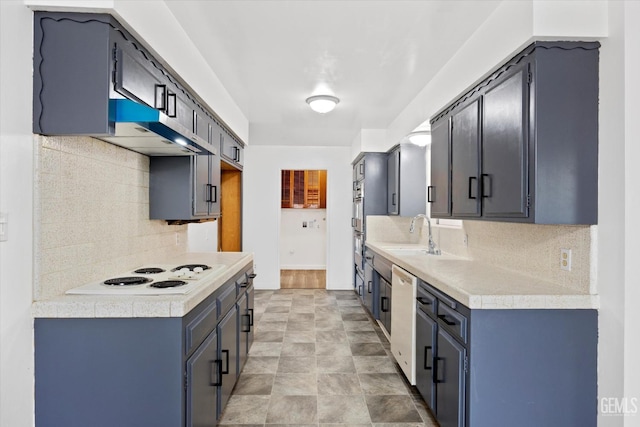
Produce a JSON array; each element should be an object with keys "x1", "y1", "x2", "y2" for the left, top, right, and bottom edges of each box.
[{"x1": 279, "y1": 169, "x2": 327, "y2": 289}]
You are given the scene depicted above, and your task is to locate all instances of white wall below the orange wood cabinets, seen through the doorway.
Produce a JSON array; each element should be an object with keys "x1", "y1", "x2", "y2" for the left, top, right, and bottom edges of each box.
[{"x1": 280, "y1": 209, "x2": 327, "y2": 270}]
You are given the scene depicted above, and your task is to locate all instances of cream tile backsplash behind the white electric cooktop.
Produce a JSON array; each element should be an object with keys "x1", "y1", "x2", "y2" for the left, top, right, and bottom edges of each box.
[{"x1": 34, "y1": 136, "x2": 187, "y2": 300}]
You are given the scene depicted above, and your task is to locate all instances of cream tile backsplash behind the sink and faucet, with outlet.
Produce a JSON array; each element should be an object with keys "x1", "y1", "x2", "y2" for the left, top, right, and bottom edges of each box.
[{"x1": 367, "y1": 216, "x2": 597, "y2": 294}]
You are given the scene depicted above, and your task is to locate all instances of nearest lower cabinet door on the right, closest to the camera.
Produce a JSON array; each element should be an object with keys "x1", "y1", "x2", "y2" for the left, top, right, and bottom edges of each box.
[{"x1": 434, "y1": 328, "x2": 466, "y2": 427}]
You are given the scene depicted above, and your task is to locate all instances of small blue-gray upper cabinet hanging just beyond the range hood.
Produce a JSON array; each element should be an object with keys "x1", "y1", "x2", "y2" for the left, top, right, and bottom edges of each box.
[{"x1": 149, "y1": 154, "x2": 220, "y2": 221}]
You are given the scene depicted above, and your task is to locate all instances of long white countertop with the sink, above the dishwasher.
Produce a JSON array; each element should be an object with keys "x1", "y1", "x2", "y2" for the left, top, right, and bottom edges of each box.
[{"x1": 366, "y1": 241, "x2": 599, "y2": 309}]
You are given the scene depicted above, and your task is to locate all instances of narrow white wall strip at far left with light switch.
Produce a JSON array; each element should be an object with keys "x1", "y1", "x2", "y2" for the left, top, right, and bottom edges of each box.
[{"x1": 0, "y1": 1, "x2": 34, "y2": 426}]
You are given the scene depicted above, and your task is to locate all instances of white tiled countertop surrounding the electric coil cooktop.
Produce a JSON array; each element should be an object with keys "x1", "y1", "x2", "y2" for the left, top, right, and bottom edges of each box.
[{"x1": 31, "y1": 252, "x2": 253, "y2": 318}]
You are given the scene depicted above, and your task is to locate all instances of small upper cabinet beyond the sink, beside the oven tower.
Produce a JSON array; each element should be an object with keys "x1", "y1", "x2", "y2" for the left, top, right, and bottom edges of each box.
[{"x1": 387, "y1": 144, "x2": 427, "y2": 216}]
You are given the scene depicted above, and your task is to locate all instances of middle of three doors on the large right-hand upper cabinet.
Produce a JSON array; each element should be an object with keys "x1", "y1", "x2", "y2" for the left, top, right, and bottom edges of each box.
[{"x1": 451, "y1": 99, "x2": 480, "y2": 217}]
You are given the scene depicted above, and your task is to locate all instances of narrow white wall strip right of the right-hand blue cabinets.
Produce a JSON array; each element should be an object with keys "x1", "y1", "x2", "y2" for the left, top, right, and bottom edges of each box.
[{"x1": 596, "y1": 2, "x2": 638, "y2": 427}]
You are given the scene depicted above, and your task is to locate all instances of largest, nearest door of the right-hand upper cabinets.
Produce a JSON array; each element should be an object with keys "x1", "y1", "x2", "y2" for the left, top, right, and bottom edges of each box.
[{"x1": 481, "y1": 64, "x2": 529, "y2": 218}]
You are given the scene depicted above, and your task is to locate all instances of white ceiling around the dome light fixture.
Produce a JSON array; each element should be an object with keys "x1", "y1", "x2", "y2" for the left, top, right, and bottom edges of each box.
[{"x1": 166, "y1": 0, "x2": 500, "y2": 146}]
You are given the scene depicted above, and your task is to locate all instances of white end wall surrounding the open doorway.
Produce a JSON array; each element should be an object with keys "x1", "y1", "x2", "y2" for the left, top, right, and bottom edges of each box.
[{"x1": 242, "y1": 145, "x2": 352, "y2": 289}]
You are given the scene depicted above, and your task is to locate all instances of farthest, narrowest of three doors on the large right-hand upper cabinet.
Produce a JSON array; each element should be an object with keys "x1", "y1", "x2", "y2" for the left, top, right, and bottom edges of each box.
[{"x1": 427, "y1": 119, "x2": 451, "y2": 217}]
